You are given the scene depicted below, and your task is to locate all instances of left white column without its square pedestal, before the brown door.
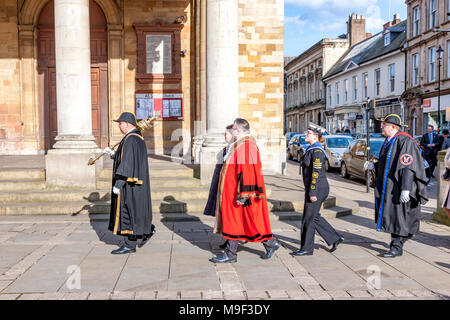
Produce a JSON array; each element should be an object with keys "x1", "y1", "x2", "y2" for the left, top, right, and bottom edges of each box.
[{"x1": 53, "y1": 0, "x2": 97, "y2": 149}]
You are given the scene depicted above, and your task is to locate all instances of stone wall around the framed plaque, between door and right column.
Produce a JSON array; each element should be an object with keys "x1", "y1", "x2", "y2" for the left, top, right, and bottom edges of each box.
[{"x1": 118, "y1": 0, "x2": 194, "y2": 154}]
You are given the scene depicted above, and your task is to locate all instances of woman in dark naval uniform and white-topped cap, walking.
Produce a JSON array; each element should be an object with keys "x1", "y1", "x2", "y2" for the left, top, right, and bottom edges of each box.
[{"x1": 291, "y1": 123, "x2": 344, "y2": 256}]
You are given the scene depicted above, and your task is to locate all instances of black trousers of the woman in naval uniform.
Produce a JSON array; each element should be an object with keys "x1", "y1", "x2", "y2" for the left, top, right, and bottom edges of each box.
[{"x1": 300, "y1": 190, "x2": 341, "y2": 251}]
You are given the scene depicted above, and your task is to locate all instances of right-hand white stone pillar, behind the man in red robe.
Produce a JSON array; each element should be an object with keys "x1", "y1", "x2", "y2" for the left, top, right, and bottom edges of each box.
[{"x1": 200, "y1": 0, "x2": 239, "y2": 184}]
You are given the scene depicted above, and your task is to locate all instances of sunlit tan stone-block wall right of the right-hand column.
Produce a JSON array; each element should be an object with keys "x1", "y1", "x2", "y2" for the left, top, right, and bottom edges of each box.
[{"x1": 239, "y1": 0, "x2": 285, "y2": 173}]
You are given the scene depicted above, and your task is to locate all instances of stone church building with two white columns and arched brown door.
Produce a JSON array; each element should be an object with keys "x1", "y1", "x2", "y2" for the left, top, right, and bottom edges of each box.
[{"x1": 0, "y1": 0, "x2": 285, "y2": 186}]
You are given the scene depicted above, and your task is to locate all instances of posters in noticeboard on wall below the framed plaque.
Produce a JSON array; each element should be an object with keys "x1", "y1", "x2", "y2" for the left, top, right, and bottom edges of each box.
[{"x1": 136, "y1": 92, "x2": 183, "y2": 120}]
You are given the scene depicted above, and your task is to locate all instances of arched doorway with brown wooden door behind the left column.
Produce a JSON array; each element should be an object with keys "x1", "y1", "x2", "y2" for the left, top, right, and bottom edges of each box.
[{"x1": 37, "y1": 0, "x2": 109, "y2": 150}]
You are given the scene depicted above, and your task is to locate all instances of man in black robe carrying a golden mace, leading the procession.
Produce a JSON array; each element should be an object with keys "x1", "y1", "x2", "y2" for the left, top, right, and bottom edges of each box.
[{"x1": 105, "y1": 112, "x2": 155, "y2": 254}]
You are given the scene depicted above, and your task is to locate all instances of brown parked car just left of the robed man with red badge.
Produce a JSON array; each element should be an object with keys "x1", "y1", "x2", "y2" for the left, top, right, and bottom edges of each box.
[{"x1": 341, "y1": 138, "x2": 385, "y2": 188}]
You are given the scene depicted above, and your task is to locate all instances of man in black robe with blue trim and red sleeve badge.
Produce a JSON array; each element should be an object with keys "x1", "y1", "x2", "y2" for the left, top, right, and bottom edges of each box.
[{"x1": 364, "y1": 114, "x2": 428, "y2": 258}]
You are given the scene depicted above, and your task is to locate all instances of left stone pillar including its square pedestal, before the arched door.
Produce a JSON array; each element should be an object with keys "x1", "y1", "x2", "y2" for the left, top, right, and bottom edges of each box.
[{"x1": 46, "y1": 0, "x2": 101, "y2": 188}]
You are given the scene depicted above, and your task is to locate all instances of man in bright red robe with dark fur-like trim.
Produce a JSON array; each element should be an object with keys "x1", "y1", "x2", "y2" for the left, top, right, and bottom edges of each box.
[{"x1": 210, "y1": 118, "x2": 280, "y2": 263}]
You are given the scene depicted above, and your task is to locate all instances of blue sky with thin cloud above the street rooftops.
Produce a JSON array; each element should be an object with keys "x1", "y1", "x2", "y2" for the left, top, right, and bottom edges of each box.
[{"x1": 284, "y1": 0, "x2": 407, "y2": 56}]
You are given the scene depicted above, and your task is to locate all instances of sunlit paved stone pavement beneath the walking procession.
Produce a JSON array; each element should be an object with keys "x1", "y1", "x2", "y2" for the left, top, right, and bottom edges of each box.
[{"x1": 0, "y1": 161, "x2": 450, "y2": 300}]
